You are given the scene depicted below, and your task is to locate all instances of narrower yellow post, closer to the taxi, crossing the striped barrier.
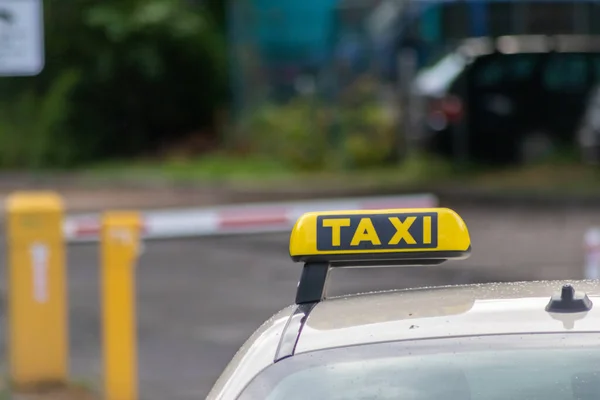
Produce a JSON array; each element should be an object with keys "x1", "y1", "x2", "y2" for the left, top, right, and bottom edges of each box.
[{"x1": 101, "y1": 211, "x2": 141, "y2": 400}]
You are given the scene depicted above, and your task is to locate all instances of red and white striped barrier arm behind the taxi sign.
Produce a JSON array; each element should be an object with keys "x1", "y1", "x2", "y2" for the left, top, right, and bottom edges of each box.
[{"x1": 64, "y1": 194, "x2": 438, "y2": 242}]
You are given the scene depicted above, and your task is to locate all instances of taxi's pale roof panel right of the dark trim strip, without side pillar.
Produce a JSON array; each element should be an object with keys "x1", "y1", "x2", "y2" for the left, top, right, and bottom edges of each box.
[{"x1": 294, "y1": 281, "x2": 600, "y2": 354}]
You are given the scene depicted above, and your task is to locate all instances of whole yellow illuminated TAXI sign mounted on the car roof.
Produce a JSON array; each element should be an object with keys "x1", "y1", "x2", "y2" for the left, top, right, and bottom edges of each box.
[{"x1": 290, "y1": 208, "x2": 471, "y2": 266}]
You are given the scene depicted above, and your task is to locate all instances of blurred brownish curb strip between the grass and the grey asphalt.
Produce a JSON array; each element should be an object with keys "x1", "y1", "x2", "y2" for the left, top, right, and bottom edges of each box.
[{"x1": 0, "y1": 180, "x2": 600, "y2": 214}]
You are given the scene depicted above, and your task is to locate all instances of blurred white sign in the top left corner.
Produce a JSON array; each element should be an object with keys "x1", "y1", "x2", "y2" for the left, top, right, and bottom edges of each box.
[{"x1": 0, "y1": 0, "x2": 45, "y2": 76}]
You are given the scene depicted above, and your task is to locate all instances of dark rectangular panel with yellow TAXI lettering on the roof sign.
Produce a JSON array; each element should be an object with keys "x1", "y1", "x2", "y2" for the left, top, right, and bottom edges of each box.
[{"x1": 317, "y1": 212, "x2": 438, "y2": 251}]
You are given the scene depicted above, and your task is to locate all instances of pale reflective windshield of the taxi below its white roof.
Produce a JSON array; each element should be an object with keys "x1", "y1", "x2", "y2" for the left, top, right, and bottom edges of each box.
[{"x1": 239, "y1": 328, "x2": 600, "y2": 400}]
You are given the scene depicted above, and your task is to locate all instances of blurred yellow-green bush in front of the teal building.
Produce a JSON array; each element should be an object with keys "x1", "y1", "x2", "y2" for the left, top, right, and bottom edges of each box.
[{"x1": 241, "y1": 98, "x2": 396, "y2": 170}]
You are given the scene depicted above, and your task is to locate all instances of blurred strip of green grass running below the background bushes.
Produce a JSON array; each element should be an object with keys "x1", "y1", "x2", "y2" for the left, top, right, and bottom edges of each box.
[{"x1": 80, "y1": 155, "x2": 600, "y2": 194}]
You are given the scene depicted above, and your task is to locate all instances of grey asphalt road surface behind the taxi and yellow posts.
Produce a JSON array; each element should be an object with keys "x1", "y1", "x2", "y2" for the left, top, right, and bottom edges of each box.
[{"x1": 0, "y1": 206, "x2": 600, "y2": 400}]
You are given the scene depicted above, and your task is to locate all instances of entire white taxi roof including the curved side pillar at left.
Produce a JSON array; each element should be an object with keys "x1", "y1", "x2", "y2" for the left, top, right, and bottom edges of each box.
[{"x1": 208, "y1": 280, "x2": 600, "y2": 399}]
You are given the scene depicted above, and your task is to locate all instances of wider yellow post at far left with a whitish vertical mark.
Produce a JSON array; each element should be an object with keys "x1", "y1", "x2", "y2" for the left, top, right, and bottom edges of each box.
[{"x1": 6, "y1": 192, "x2": 69, "y2": 388}]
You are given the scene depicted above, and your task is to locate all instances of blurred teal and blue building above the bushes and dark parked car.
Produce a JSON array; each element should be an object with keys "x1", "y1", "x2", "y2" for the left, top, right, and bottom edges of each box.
[{"x1": 229, "y1": 0, "x2": 600, "y2": 104}]
